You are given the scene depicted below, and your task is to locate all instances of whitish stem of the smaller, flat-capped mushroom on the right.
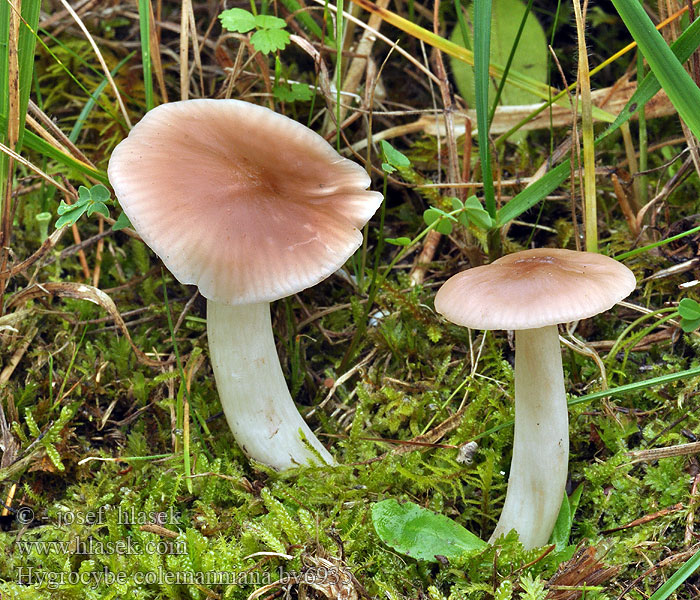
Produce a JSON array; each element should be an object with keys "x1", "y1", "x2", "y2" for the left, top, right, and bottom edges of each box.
[{"x1": 489, "y1": 325, "x2": 569, "y2": 548}]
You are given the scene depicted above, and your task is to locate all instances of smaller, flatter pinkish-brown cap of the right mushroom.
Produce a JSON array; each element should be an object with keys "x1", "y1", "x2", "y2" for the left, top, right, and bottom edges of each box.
[{"x1": 435, "y1": 248, "x2": 637, "y2": 329}]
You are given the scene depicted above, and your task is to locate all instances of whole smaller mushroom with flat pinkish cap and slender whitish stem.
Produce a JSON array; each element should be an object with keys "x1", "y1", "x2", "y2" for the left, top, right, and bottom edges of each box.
[{"x1": 435, "y1": 248, "x2": 636, "y2": 548}]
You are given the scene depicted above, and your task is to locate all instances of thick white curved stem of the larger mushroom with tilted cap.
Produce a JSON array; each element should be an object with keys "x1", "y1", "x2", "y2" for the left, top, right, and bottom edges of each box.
[{"x1": 207, "y1": 300, "x2": 335, "y2": 471}]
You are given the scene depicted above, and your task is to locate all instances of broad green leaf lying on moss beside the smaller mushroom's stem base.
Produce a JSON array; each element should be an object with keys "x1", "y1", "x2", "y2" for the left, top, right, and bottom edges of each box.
[{"x1": 372, "y1": 499, "x2": 487, "y2": 562}]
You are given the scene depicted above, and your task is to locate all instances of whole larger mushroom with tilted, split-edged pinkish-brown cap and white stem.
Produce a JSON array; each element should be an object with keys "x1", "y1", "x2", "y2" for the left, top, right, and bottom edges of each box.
[{"x1": 108, "y1": 99, "x2": 382, "y2": 470}]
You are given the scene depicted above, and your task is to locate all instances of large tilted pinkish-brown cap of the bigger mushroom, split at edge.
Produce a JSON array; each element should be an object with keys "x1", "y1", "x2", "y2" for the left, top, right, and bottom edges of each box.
[{"x1": 108, "y1": 100, "x2": 382, "y2": 304}]
